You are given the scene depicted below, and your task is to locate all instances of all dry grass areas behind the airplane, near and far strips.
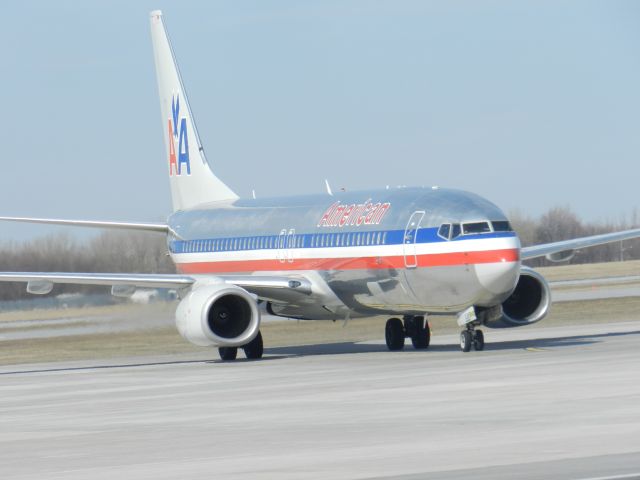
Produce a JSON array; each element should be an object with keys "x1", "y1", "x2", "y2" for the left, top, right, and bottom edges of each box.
[{"x1": 0, "y1": 262, "x2": 640, "y2": 365}]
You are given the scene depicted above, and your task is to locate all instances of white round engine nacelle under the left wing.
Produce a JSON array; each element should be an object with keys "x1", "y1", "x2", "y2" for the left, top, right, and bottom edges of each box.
[{"x1": 176, "y1": 283, "x2": 260, "y2": 347}]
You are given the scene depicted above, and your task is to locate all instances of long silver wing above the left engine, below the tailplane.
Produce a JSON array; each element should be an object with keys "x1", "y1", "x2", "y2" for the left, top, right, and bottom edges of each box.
[{"x1": 0, "y1": 272, "x2": 312, "y2": 302}]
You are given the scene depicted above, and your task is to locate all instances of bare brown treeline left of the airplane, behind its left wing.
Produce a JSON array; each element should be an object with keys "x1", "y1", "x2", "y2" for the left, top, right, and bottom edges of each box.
[{"x1": 0, "y1": 230, "x2": 175, "y2": 300}]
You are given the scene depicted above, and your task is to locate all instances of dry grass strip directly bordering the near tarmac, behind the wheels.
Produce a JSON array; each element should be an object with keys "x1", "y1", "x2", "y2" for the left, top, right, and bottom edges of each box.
[{"x1": 5, "y1": 297, "x2": 640, "y2": 365}]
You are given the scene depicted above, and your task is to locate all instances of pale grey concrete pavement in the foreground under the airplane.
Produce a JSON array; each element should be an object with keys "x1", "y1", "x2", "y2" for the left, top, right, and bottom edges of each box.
[{"x1": 0, "y1": 322, "x2": 640, "y2": 479}]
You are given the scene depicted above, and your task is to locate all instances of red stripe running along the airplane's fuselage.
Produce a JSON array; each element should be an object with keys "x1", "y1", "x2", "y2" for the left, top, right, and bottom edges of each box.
[{"x1": 177, "y1": 248, "x2": 520, "y2": 273}]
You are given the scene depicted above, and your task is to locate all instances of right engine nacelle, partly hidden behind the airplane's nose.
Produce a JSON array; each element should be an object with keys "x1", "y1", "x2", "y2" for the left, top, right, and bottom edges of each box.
[{"x1": 487, "y1": 267, "x2": 551, "y2": 328}]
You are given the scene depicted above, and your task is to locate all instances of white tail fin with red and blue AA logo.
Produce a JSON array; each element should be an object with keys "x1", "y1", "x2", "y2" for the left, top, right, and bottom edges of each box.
[{"x1": 151, "y1": 10, "x2": 238, "y2": 210}]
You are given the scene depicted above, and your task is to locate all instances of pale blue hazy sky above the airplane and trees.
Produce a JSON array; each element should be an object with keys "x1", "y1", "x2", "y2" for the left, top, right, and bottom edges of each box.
[{"x1": 0, "y1": 0, "x2": 640, "y2": 240}]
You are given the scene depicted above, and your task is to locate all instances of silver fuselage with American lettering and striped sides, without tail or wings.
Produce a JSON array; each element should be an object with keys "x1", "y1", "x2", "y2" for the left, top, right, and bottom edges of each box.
[{"x1": 169, "y1": 188, "x2": 520, "y2": 319}]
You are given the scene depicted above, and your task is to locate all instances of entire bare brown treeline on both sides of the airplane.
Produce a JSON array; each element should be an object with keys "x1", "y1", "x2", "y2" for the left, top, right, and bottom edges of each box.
[{"x1": 0, "y1": 207, "x2": 640, "y2": 300}]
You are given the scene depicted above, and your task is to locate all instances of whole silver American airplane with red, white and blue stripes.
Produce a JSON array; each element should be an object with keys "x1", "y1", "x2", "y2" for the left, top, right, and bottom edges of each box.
[{"x1": 0, "y1": 10, "x2": 640, "y2": 360}]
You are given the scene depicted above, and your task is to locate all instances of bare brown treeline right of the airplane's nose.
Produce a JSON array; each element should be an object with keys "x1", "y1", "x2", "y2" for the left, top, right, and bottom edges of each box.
[{"x1": 509, "y1": 207, "x2": 640, "y2": 266}]
